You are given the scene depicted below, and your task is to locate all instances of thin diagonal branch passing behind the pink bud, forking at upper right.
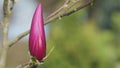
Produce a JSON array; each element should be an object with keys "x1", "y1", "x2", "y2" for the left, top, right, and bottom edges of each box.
[{"x1": 8, "y1": 0, "x2": 94, "y2": 47}]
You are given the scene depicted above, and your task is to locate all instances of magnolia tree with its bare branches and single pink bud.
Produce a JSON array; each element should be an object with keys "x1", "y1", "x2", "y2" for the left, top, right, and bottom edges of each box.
[{"x1": 0, "y1": 0, "x2": 93, "y2": 68}]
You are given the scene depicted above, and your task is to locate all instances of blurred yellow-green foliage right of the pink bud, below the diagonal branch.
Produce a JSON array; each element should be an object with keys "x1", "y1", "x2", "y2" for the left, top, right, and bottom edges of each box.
[{"x1": 37, "y1": 0, "x2": 120, "y2": 68}]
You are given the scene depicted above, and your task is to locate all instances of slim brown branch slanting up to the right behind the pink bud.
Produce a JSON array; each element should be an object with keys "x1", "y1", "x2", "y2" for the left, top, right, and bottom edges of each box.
[{"x1": 8, "y1": 0, "x2": 94, "y2": 47}]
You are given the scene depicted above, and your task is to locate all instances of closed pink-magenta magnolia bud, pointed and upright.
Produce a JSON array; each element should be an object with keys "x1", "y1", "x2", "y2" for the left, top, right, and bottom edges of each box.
[{"x1": 29, "y1": 4, "x2": 46, "y2": 61}]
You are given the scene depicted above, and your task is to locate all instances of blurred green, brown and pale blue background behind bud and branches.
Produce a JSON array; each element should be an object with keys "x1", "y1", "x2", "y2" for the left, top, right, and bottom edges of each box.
[{"x1": 0, "y1": 0, "x2": 120, "y2": 68}]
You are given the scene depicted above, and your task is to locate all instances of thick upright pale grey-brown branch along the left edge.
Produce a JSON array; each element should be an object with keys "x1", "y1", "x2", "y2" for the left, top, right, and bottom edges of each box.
[{"x1": 0, "y1": 0, "x2": 11, "y2": 68}]
